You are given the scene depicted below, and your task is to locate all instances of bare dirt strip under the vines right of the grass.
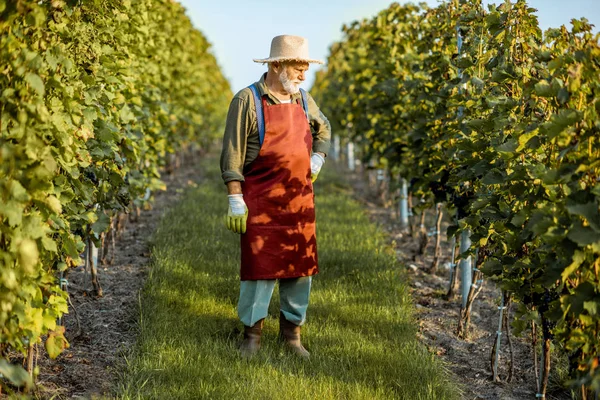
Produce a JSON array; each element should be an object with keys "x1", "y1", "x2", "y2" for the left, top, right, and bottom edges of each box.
[{"x1": 340, "y1": 163, "x2": 571, "y2": 400}]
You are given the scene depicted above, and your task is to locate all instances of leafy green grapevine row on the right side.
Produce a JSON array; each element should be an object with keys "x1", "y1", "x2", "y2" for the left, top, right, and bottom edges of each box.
[{"x1": 312, "y1": 0, "x2": 600, "y2": 392}]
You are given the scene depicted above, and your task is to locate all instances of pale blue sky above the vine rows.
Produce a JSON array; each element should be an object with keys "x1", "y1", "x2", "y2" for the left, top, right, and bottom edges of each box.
[{"x1": 178, "y1": 0, "x2": 600, "y2": 92}]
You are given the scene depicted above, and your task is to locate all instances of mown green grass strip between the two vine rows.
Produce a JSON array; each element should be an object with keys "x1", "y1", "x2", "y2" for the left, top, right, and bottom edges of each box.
[{"x1": 118, "y1": 159, "x2": 460, "y2": 400}]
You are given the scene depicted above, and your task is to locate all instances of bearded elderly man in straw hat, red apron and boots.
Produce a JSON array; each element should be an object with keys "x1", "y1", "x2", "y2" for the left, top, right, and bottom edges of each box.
[{"x1": 221, "y1": 35, "x2": 331, "y2": 358}]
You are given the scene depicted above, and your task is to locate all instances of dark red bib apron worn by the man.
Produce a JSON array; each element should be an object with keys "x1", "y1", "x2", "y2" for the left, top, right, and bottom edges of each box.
[{"x1": 240, "y1": 98, "x2": 318, "y2": 281}]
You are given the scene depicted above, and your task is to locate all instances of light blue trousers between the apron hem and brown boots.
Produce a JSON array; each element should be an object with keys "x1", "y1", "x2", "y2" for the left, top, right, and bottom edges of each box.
[{"x1": 238, "y1": 276, "x2": 312, "y2": 326}]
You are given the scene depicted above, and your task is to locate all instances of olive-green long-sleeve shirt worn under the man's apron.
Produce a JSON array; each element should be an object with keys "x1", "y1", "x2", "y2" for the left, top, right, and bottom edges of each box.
[{"x1": 221, "y1": 73, "x2": 331, "y2": 183}]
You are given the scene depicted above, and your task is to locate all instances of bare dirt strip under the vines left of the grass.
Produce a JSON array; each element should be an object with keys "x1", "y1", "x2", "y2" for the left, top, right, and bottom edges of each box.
[{"x1": 38, "y1": 154, "x2": 206, "y2": 399}]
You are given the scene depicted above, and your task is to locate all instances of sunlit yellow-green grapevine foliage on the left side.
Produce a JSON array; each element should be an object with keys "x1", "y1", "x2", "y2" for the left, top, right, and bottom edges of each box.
[{"x1": 0, "y1": 0, "x2": 231, "y2": 382}]
